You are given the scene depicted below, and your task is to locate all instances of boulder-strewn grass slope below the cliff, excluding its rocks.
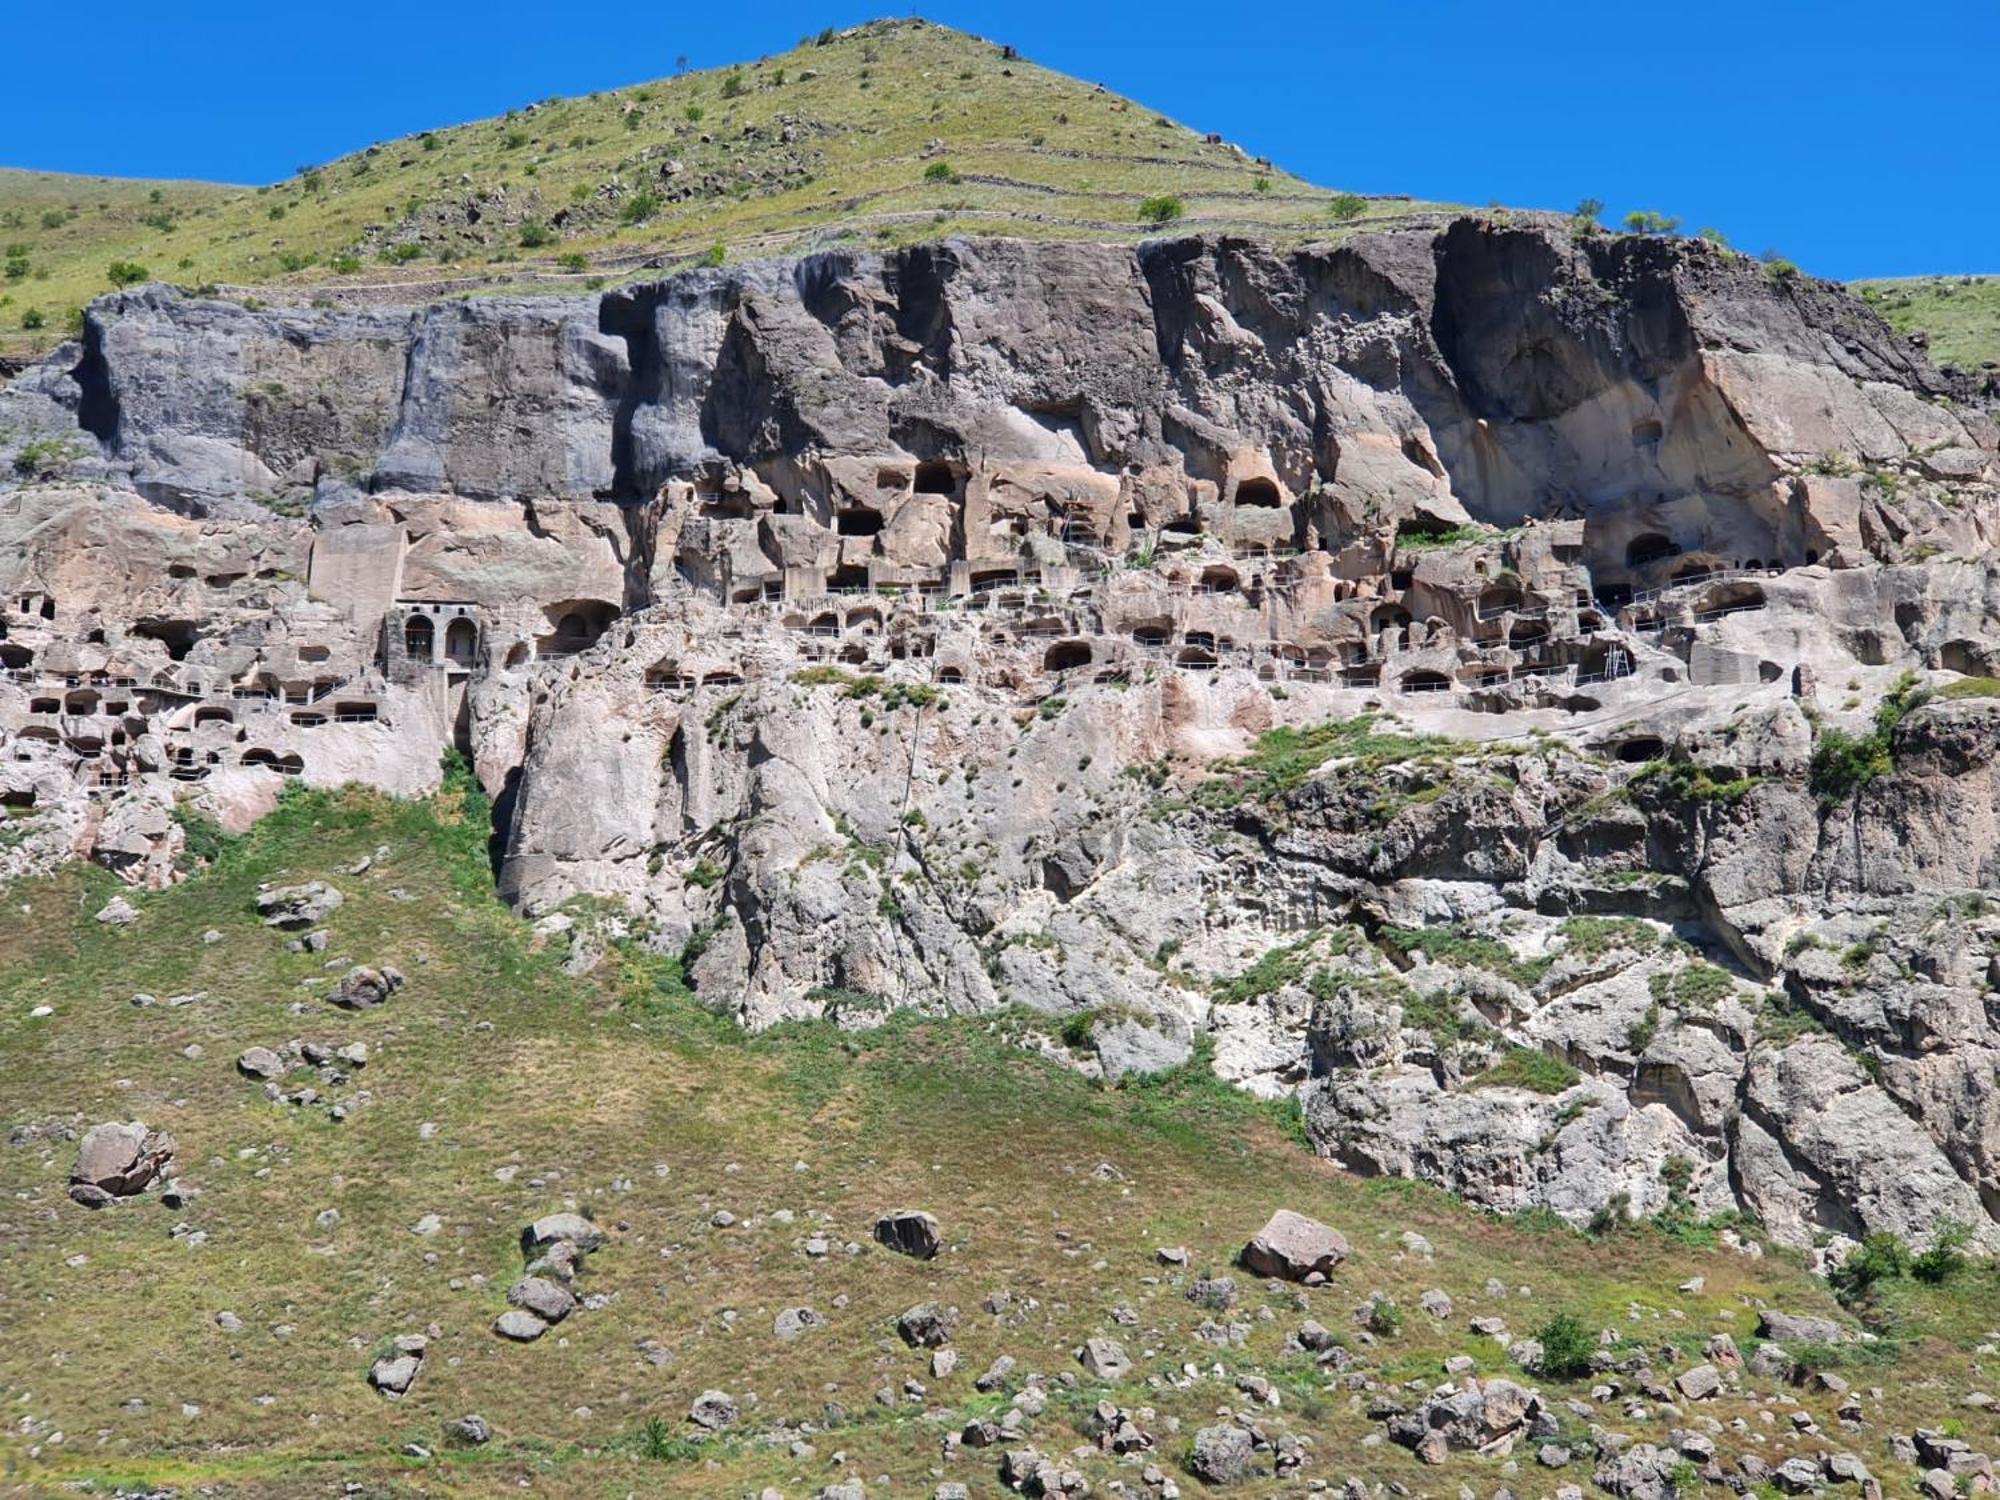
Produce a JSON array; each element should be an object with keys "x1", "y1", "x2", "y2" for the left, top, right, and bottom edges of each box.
[{"x1": 0, "y1": 778, "x2": 2000, "y2": 1496}]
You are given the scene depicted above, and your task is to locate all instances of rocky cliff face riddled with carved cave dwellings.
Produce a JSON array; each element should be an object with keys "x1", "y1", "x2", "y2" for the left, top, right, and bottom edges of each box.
[{"x1": 0, "y1": 220, "x2": 2000, "y2": 1244}]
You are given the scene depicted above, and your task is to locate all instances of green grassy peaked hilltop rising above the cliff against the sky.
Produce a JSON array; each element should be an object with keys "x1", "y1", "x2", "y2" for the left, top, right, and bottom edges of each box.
[{"x1": 0, "y1": 20, "x2": 1440, "y2": 362}]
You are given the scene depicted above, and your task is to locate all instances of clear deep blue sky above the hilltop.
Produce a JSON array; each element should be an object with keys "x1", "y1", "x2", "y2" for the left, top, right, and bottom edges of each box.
[{"x1": 0, "y1": 0, "x2": 2000, "y2": 278}]
